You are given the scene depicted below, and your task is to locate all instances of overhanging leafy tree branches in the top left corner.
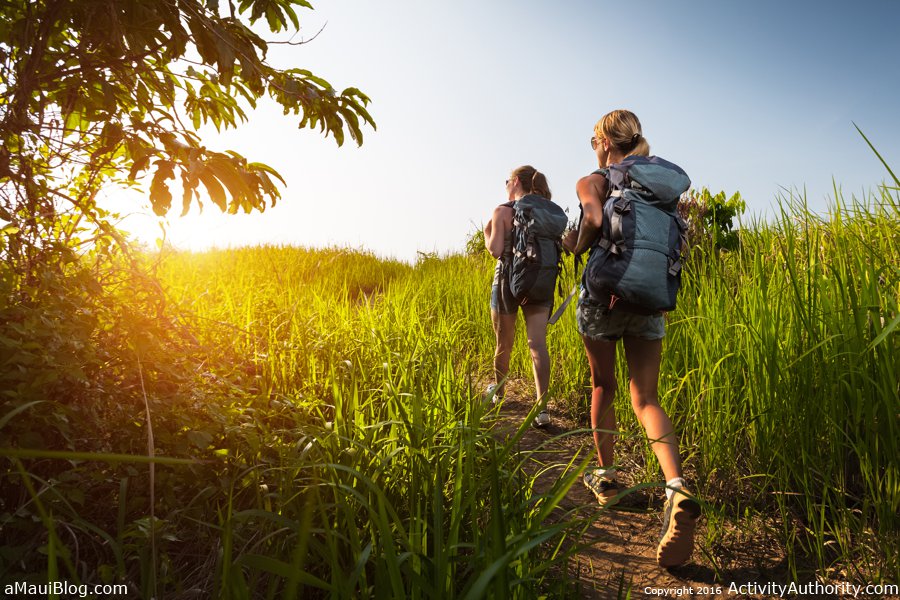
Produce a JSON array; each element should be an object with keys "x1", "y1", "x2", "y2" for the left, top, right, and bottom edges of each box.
[{"x1": 0, "y1": 0, "x2": 374, "y2": 265}]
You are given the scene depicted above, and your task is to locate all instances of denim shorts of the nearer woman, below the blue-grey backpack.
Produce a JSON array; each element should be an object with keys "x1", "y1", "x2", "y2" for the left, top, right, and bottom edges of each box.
[{"x1": 575, "y1": 288, "x2": 666, "y2": 342}]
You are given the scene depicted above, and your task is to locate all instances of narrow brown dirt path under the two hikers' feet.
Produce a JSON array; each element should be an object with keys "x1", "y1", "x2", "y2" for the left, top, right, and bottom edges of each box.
[{"x1": 488, "y1": 392, "x2": 813, "y2": 598}]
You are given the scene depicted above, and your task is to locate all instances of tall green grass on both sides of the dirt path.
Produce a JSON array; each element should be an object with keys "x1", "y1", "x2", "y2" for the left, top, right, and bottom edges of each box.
[{"x1": 0, "y1": 175, "x2": 900, "y2": 598}]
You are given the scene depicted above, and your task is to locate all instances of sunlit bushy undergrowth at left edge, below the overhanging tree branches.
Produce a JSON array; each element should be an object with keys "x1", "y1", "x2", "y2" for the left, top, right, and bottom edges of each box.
[{"x1": 0, "y1": 246, "x2": 236, "y2": 597}]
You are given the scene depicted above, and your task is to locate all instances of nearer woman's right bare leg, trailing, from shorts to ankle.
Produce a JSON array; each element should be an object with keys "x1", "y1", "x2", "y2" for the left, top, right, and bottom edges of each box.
[{"x1": 624, "y1": 337, "x2": 681, "y2": 481}]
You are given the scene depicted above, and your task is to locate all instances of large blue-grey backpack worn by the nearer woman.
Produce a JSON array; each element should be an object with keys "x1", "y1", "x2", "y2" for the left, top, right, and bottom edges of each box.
[{"x1": 583, "y1": 156, "x2": 691, "y2": 314}]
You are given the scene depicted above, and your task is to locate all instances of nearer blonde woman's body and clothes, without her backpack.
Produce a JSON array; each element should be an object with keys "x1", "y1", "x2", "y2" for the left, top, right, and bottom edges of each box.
[{"x1": 563, "y1": 110, "x2": 700, "y2": 567}]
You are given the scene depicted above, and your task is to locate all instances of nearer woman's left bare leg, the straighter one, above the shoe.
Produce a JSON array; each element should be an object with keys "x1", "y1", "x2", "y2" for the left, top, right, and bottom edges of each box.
[{"x1": 582, "y1": 337, "x2": 617, "y2": 468}]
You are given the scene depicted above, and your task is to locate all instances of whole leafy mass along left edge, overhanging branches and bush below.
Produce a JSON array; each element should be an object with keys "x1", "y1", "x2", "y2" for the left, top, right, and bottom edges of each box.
[{"x1": 0, "y1": 0, "x2": 384, "y2": 597}]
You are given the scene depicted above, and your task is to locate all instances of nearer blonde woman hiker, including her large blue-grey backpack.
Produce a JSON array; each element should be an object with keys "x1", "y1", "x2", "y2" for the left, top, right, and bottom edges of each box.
[{"x1": 563, "y1": 110, "x2": 700, "y2": 567}]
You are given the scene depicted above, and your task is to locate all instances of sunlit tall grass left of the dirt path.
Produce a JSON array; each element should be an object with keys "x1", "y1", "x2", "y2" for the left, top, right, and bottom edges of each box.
[{"x1": 152, "y1": 248, "x2": 578, "y2": 598}]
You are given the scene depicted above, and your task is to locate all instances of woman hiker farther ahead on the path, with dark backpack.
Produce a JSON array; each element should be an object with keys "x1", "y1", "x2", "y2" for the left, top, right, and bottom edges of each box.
[{"x1": 484, "y1": 165, "x2": 567, "y2": 427}]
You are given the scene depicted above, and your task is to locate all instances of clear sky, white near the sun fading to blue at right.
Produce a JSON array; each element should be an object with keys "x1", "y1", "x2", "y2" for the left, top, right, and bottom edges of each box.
[{"x1": 116, "y1": 0, "x2": 900, "y2": 260}]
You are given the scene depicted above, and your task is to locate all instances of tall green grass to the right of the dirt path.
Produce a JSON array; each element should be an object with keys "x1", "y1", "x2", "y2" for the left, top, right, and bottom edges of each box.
[{"x1": 544, "y1": 186, "x2": 900, "y2": 581}]
